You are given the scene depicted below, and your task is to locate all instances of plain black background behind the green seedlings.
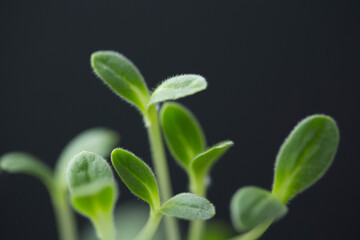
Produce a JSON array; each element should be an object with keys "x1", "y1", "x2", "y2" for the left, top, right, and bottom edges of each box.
[{"x1": 0, "y1": 0, "x2": 360, "y2": 240}]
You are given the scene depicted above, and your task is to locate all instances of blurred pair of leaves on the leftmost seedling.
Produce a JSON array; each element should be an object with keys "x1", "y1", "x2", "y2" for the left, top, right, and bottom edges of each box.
[{"x1": 0, "y1": 128, "x2": 119, "y2": 191}]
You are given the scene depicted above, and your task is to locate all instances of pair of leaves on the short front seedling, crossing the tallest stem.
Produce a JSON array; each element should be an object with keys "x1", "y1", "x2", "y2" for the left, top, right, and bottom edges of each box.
[{"x1": 111, "y1": 149, "x2": 215, "y2": 220}]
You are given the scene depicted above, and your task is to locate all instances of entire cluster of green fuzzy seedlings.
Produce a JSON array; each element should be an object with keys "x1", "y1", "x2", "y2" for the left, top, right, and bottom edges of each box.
[{"x1": 0, "y1": 51, "x2": 339, "y2": 240}]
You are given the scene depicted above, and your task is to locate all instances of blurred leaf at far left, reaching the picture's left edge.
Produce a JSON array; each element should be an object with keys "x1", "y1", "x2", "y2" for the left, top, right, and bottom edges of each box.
[{"x1": 0, "y1": 152, "x2": 54, "y2": 190}]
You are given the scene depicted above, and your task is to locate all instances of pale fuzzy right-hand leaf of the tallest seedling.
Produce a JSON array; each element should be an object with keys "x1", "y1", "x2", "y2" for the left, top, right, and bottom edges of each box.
[{"x1": 148, "y1": 74, "x2": 207, "y2": 106}]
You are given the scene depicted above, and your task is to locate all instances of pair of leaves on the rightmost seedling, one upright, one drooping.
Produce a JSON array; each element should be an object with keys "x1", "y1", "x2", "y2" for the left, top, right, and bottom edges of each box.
[{"x1": 231, "y1": 115, "x2": 339, "y2": 231}]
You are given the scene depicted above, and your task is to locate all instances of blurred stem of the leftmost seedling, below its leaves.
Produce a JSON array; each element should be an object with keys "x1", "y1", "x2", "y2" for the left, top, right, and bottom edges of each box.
[{"x1": 49, "y1": 187, "x2": 77, "y2": 240}]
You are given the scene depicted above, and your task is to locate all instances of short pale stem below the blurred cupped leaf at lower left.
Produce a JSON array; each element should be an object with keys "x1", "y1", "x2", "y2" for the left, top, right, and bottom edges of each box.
[{"x1": 94, "y1": 211, "x2": 115, "y2": 240}]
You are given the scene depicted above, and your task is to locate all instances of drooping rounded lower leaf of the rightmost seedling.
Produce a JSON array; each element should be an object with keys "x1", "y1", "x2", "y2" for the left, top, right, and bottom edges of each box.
[{"x1": 230, "y1": 186, "x2": 287, "y2": 231}]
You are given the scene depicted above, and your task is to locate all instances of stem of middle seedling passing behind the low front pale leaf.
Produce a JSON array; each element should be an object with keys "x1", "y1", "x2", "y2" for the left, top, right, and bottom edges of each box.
[{"x1": 188, "y1": 173, "x2": 206, "y2": 240}]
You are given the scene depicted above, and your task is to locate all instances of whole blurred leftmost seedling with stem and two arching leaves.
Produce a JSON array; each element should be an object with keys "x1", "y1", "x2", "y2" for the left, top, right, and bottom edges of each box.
[{"x1": 0, "y1": 128, "x2": 119, "y2": 240}]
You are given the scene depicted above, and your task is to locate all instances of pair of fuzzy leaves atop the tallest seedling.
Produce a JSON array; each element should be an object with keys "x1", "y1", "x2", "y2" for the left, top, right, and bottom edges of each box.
[{"x1": 91, "y1": 51, "x2": 207, "y2": 115}]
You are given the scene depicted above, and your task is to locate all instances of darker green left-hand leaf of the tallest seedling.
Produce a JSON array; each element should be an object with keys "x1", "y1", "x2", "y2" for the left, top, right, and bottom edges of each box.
[{"x1": 91, "y1": 51, "x2": 149, "y2": 113}]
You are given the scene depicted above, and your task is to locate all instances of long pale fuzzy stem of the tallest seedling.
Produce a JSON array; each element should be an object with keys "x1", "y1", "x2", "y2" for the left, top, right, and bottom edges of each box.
[{"x1": 145, "y1": 106, "x2": 180, "y2": 240}]
